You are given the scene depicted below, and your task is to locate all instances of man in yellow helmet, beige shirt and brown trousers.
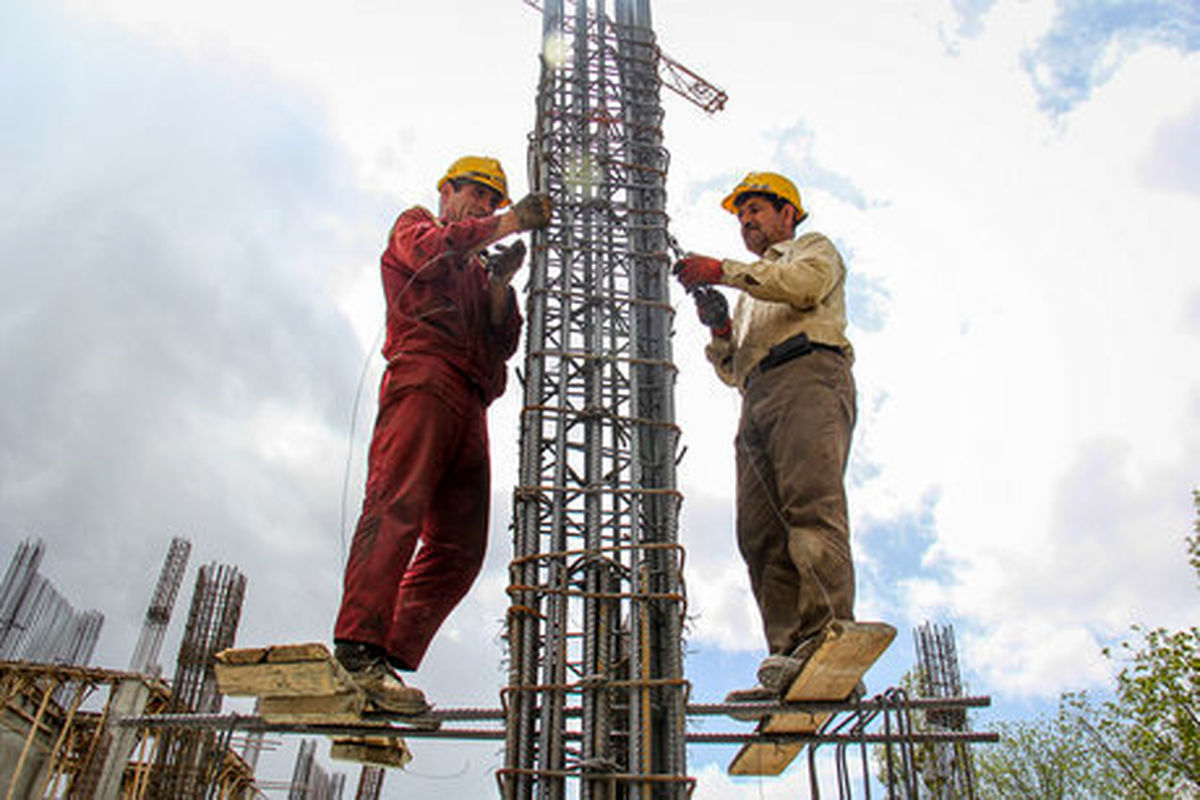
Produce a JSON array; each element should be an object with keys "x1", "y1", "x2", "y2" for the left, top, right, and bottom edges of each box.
[{"x1": 674, "y1": 173, "x2": 856, "y2": 703}]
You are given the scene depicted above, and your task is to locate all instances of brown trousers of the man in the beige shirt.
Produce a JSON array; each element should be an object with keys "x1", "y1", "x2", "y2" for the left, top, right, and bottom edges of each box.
[{"x1": 736, "y1": 349, "x2": 857, "y2": 654}]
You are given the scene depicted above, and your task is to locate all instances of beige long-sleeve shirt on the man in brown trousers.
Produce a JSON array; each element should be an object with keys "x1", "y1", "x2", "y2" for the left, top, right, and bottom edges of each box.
[{"x1": 704, "y1": 233, "x2": 854, "y2": 390}]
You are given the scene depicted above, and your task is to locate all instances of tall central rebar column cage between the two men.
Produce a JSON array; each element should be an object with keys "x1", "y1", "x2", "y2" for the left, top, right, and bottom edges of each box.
[{"x1": 499, "y1": 0, "x2": 691, "y2": 799}]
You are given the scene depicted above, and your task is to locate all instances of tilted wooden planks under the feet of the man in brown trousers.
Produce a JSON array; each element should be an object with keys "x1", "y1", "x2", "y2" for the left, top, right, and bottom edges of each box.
[{"x1": 730, "y1": 620, "x2": 896, "y2": 775}]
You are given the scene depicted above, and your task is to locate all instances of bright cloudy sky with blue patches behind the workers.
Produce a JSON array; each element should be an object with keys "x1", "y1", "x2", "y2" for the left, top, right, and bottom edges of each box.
[{"x1": 0, "y1": 0, "x2": 1200, "y2": 798}]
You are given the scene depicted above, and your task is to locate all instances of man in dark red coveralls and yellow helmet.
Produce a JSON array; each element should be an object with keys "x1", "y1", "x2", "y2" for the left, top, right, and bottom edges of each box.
[{"x1": 334, "y1": 156, "x2": 552, "y2": 715}]
